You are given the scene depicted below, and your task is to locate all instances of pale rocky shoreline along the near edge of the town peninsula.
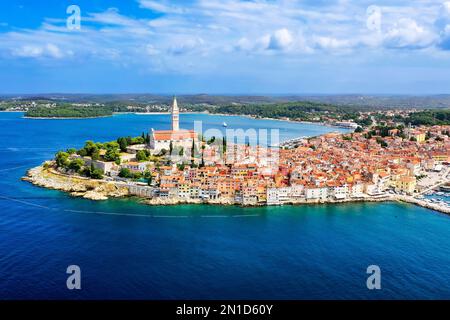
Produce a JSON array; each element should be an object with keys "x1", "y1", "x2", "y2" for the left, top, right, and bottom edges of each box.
[{"x1": 22, "y1": 166, "x2": 450, "y2": 214}]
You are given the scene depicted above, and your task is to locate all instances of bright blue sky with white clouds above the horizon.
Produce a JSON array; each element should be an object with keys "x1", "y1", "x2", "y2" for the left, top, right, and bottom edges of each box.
[{"x1": 0, "y1": 0, "x2": 450, "y2": 94}]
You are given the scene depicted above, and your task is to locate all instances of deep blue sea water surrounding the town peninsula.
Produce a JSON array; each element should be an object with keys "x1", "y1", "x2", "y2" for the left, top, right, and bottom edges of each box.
[{"x1": 0, "y1": 113, "x2": 450, "y2": 299}]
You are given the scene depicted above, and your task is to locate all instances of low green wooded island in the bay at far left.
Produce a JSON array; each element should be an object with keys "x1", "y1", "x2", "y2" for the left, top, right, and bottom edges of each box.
[{"x1": 25, "y1": 105, "x2": 113, "y2": 118}]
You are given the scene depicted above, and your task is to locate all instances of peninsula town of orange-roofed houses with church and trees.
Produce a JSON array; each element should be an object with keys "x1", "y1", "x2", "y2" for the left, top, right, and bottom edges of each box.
[{"x1": 25, "y1": 98, "x2": 450, "y2": 213}]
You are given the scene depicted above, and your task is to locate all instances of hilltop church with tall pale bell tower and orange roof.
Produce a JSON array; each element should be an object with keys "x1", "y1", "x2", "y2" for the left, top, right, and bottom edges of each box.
[{"x1": 150, "y1": 97, "x2": 199, "y2": 153}]
